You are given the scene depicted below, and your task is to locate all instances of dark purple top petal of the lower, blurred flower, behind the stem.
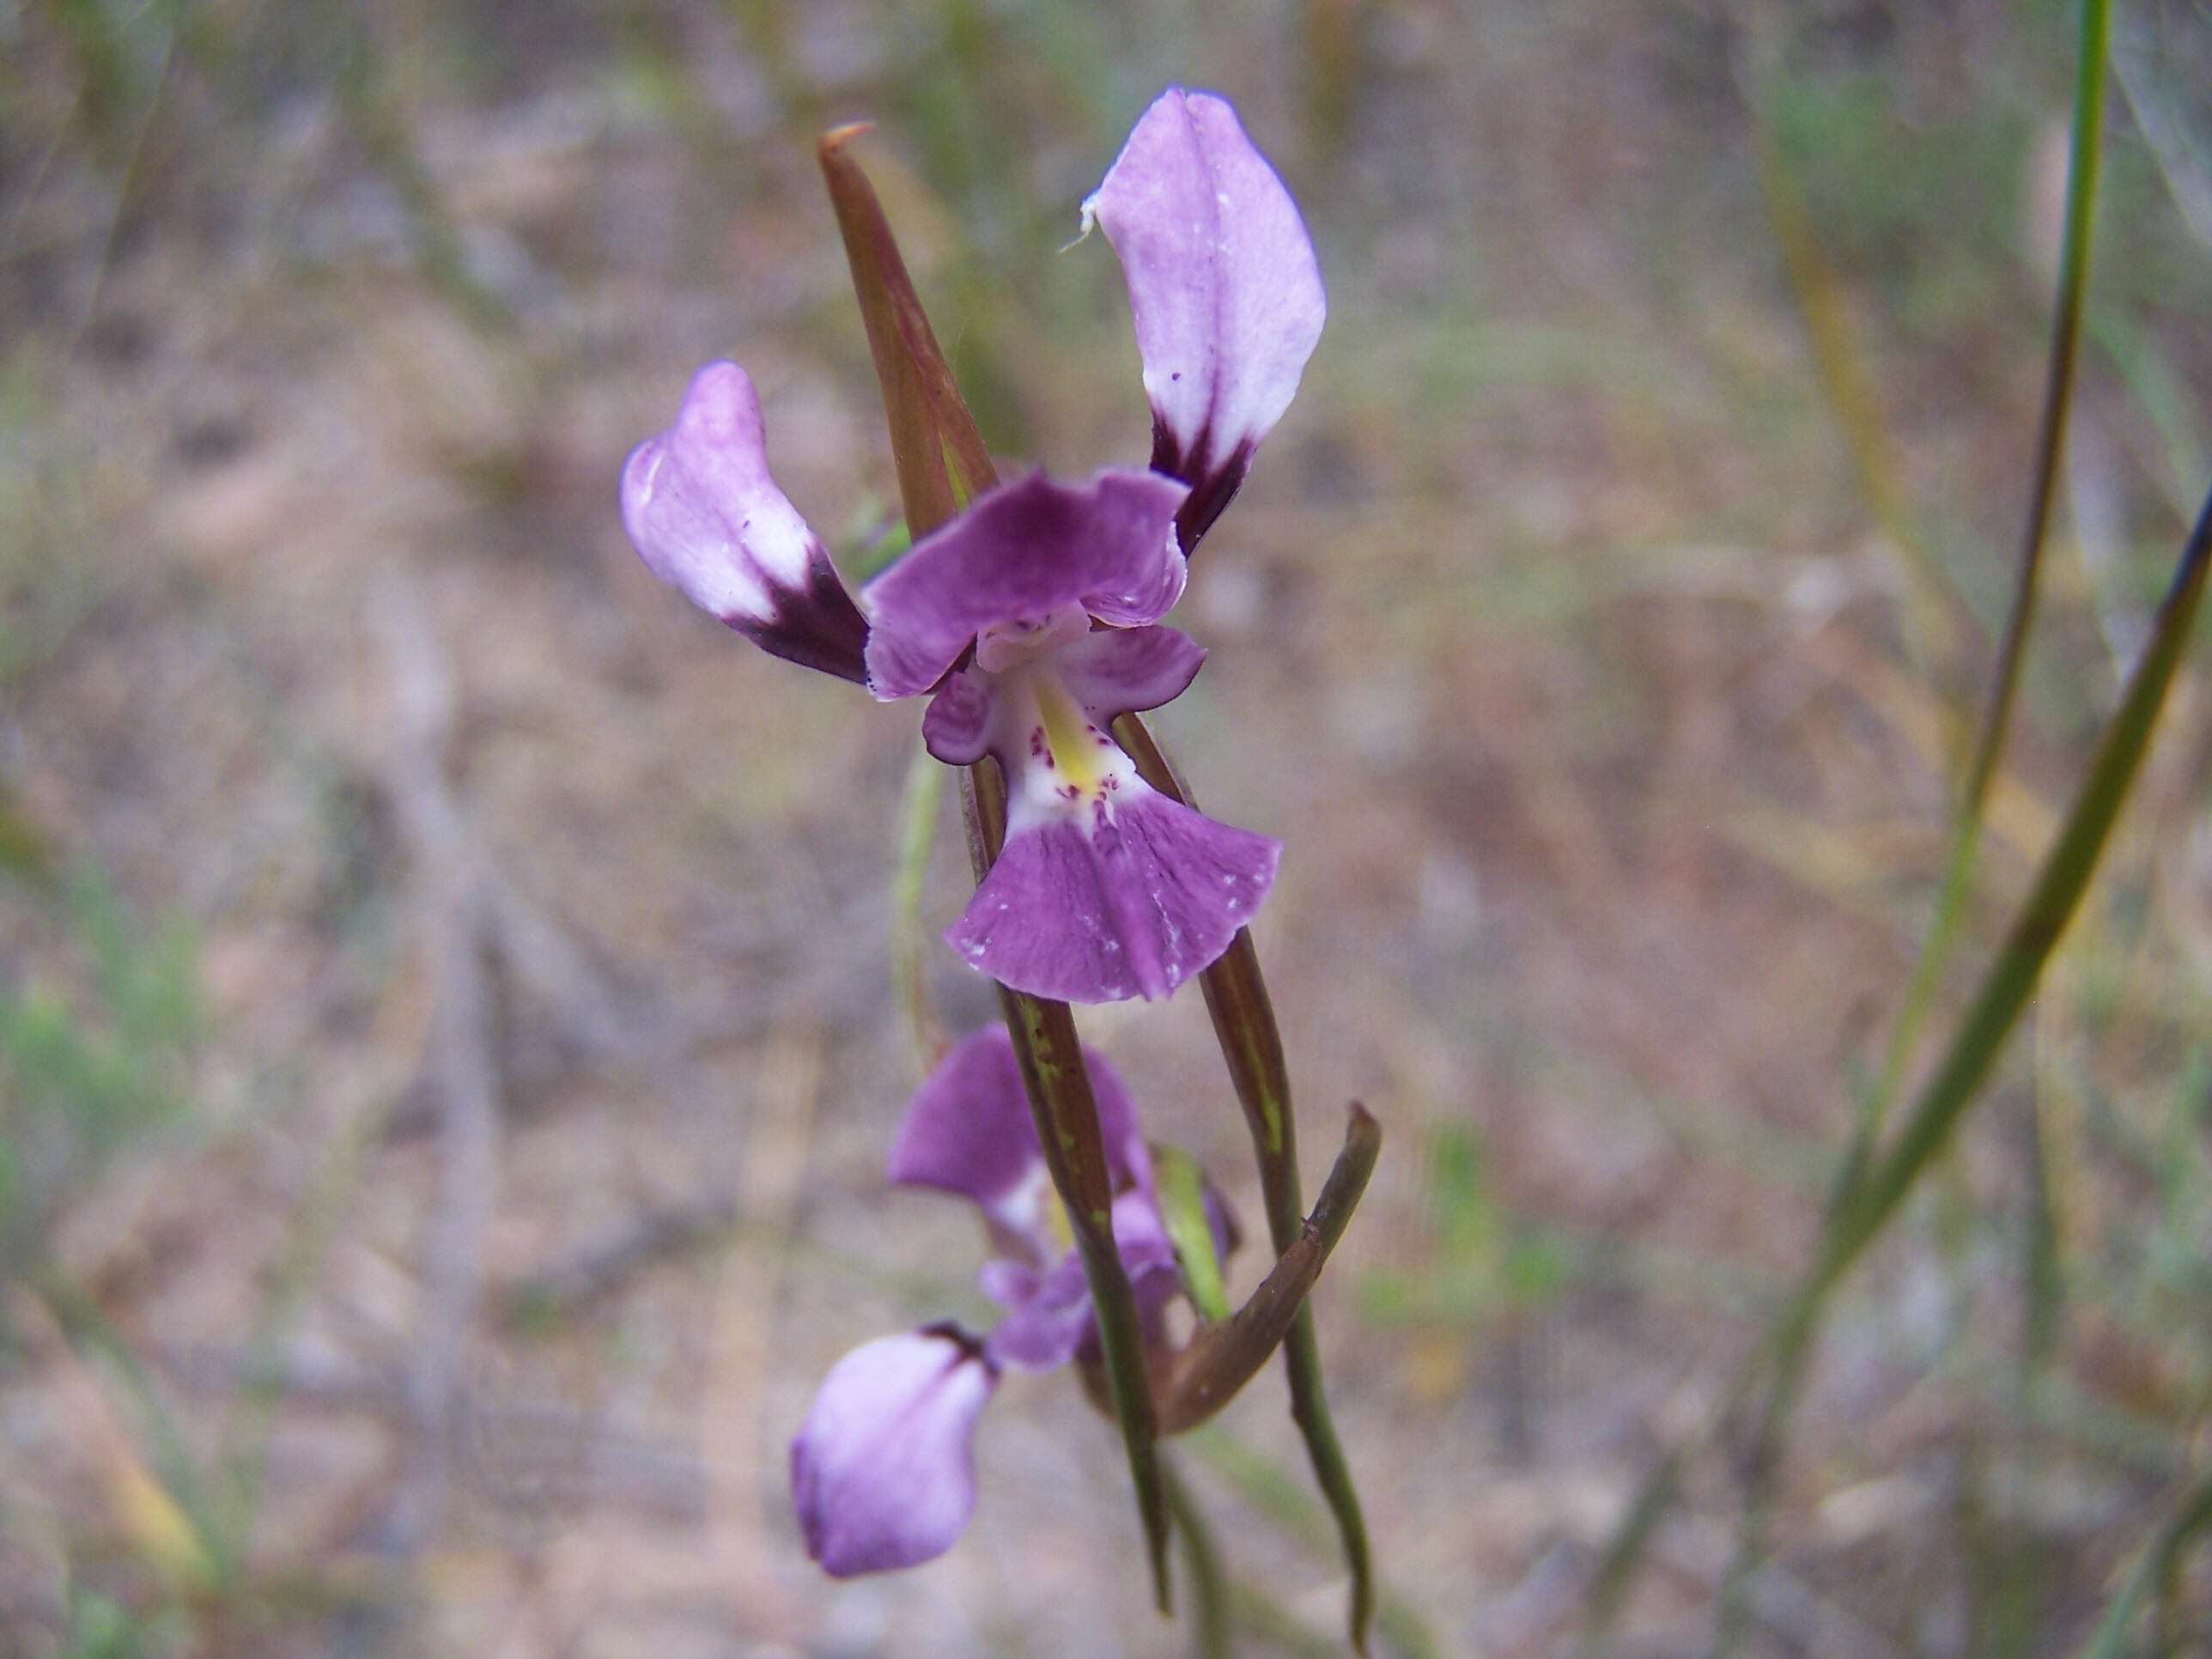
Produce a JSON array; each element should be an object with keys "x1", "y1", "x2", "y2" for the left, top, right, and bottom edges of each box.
[{"x1": 887, "y1": 1026, "x2": 1152, "y2": 1237}]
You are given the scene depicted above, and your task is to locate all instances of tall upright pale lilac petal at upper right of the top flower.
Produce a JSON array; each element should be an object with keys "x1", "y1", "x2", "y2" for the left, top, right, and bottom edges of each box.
[{"x1": 1084, "y1": 86, "x2": 1328, "y2": 550}]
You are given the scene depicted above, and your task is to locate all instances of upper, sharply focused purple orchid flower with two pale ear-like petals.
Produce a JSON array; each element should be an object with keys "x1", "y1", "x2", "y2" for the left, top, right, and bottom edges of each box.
[{"x1": 622, "y1": 88, "x2": 1325, "y2": 1002}]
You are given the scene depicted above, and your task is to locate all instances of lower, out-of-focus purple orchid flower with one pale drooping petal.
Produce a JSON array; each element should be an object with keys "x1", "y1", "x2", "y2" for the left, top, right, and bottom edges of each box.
[{"x1": 792, "y1": 1026, "x2": 1234, "y2": 1577}]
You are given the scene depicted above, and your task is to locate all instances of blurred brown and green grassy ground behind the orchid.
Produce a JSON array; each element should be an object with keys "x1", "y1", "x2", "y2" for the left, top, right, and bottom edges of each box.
[{"x1": 0, "y1": 0, "x2": 2212, "y2": 1659}]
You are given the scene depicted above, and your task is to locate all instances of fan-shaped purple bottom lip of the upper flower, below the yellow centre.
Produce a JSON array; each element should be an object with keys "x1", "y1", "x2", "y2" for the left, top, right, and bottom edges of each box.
[{"x1": 945, "y1": 779, "x2": 1283, "y2": 1002}]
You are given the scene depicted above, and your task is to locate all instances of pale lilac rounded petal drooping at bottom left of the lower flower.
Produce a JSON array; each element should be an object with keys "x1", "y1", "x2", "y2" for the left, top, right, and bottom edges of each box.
[{"x1": 792, "y1": 1325, "x2": 998, "y2": 1579}]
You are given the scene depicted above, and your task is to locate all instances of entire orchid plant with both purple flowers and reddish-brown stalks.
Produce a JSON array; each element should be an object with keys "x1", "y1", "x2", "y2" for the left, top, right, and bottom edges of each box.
[{"x1": 622, "y1": 91, "x2": 1376, "y2": 1641}]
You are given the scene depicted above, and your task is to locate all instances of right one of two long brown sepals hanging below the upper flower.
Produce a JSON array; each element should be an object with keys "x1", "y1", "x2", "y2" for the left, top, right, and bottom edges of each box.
[{"x1": 1113, "y1": 714, "x2": 1376, "y2": 1652}]
